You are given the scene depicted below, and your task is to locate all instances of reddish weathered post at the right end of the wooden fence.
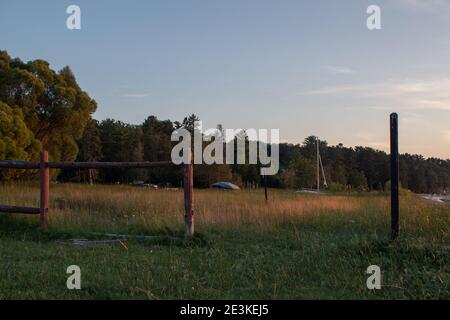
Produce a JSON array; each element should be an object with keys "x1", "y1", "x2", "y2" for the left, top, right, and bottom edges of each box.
[{"x1": 184, "y1": 151, "x2": 194, "y2": 236}]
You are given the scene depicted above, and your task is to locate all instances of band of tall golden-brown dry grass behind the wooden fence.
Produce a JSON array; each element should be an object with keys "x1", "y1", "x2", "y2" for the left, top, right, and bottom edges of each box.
[{"x1": 0, "y1": 184, "x2": 368, "y2": 230}]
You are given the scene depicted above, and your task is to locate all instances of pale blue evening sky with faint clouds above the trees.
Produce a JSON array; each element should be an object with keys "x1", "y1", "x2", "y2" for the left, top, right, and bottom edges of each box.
[{"x1": 0, "y1": 0, "x2": 450, "y2": 158}]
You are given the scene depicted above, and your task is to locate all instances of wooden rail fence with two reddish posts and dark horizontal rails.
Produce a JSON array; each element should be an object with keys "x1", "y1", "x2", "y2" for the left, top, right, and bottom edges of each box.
[{"x1": 0, "y1": 151, "x2": 194, "y2": 236}]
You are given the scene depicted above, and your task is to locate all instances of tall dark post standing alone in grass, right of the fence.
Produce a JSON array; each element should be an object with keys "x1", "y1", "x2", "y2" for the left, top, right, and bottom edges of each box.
[{"x1": 390, "y1": 113, "x2": 399, "y2": 240}]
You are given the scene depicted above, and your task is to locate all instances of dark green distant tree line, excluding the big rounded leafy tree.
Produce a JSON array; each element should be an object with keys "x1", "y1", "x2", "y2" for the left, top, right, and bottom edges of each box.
[{"x1": 62, "y1": 115, "x2": 450, "y2": 193}]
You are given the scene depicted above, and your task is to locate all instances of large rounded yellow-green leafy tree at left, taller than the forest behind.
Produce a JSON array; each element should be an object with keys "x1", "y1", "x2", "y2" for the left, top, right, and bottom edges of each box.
[{"x1": 0, "y1": 51, "x2": 97, "y2": 161}]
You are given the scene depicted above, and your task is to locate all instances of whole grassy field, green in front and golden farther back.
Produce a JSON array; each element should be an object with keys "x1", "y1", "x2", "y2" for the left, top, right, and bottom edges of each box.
[{"x1": 0, "y1": 184, "x2": 450, "y2": 299}]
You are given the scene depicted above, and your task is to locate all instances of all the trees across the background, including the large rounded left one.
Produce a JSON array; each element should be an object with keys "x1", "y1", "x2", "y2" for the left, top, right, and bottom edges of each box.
[{"x1": 0, "y1": 51, "x2": 450, "y2": 193}]
